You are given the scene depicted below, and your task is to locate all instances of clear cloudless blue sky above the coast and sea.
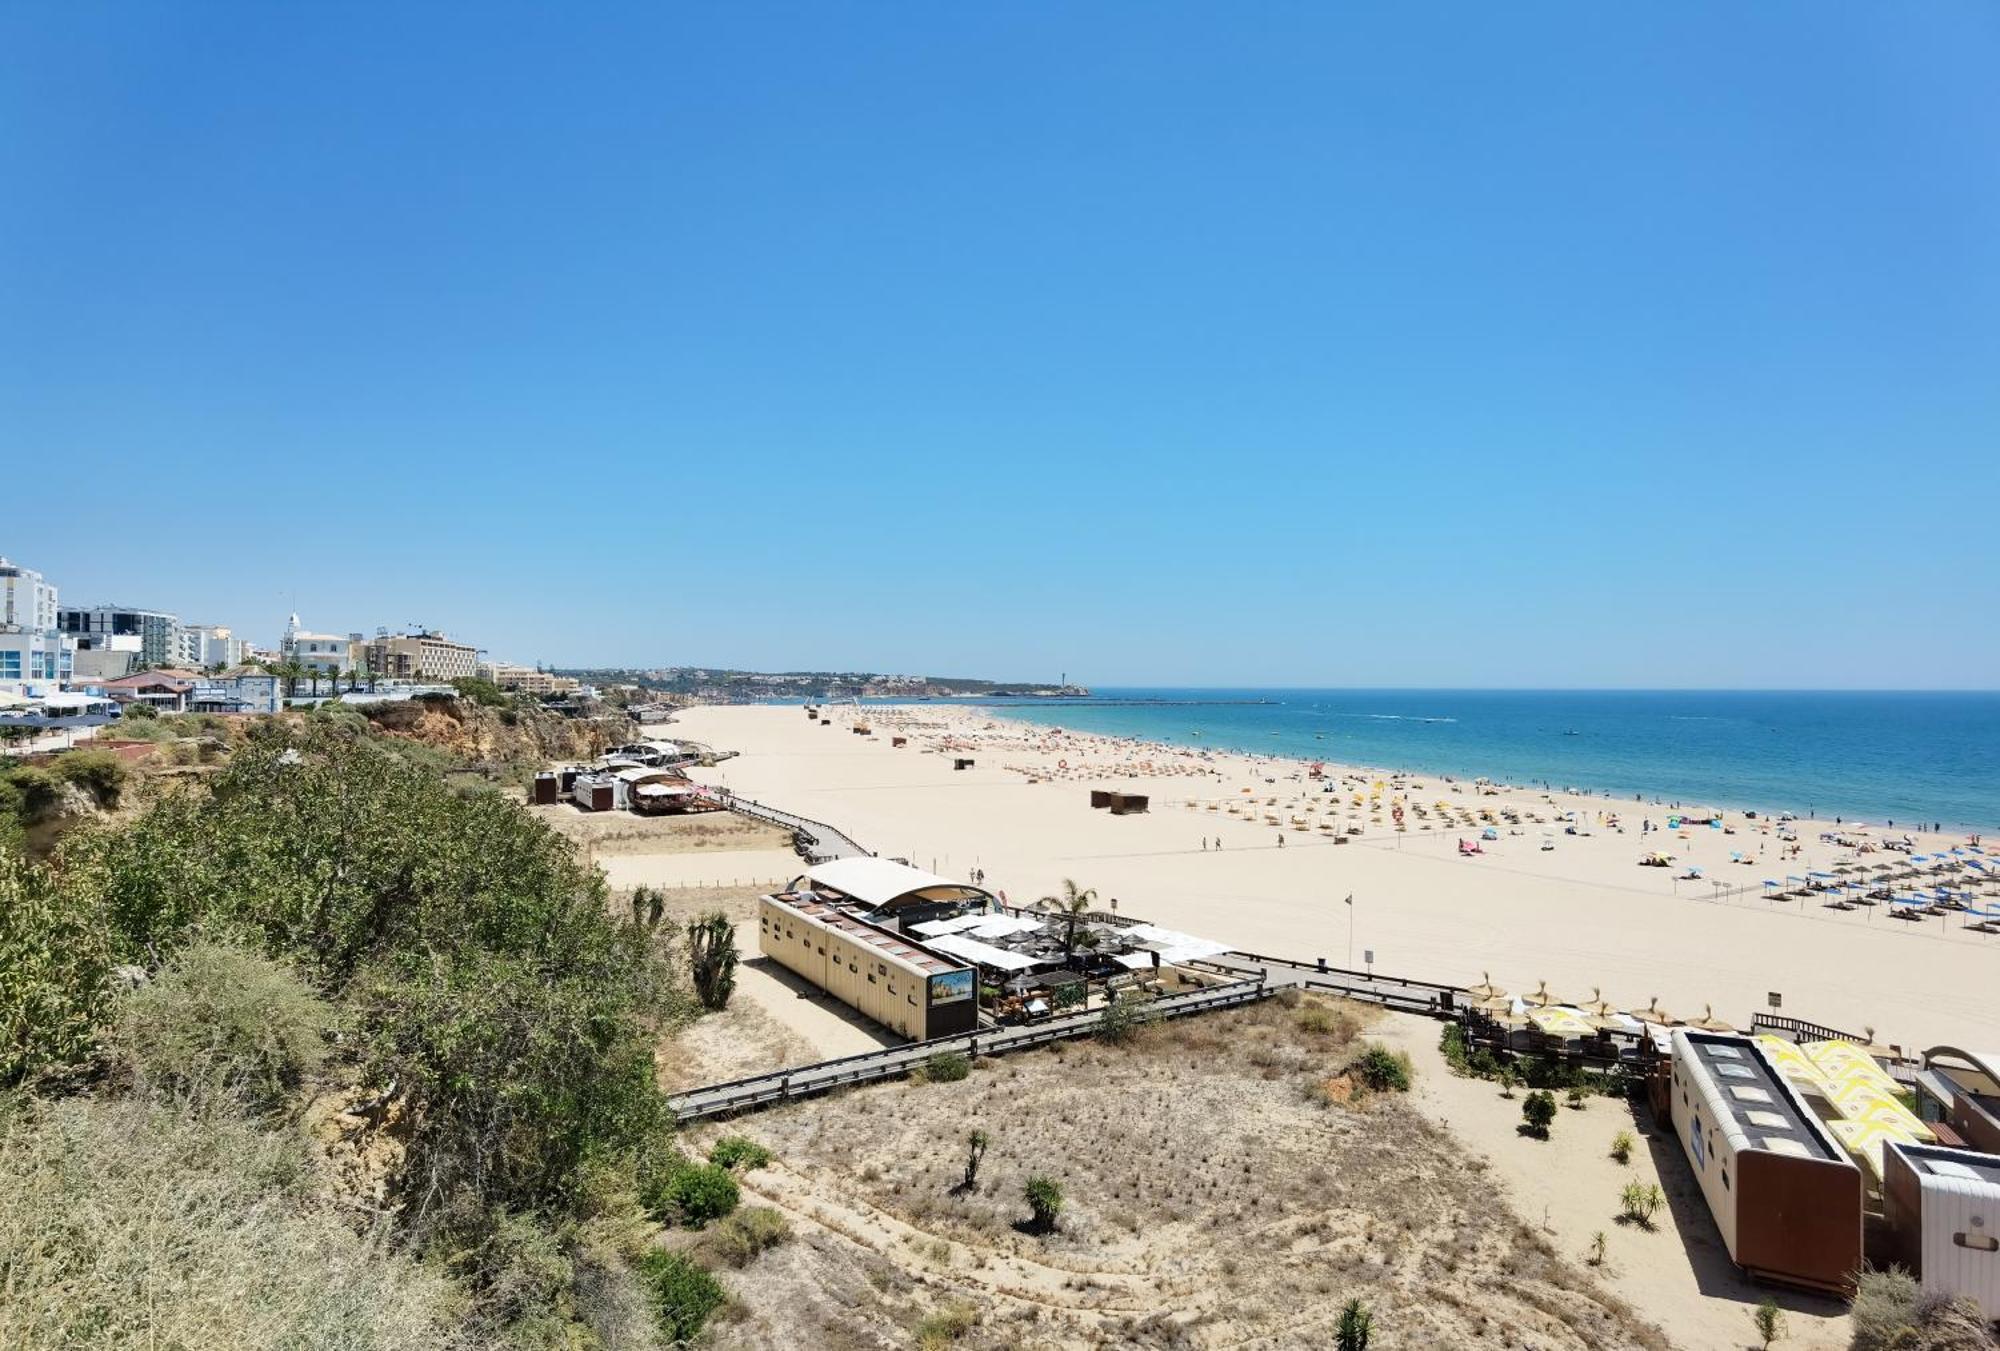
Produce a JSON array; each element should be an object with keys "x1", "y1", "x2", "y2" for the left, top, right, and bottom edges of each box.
[{"x1": 0, "y1": 0, "x2": 2000, "y2": 687}]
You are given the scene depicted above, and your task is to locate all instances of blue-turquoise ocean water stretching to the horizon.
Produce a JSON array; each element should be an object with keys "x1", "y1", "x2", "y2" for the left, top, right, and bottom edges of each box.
[{"x1": 916, "y1": 689, "x2": 2000, "y2": 829}]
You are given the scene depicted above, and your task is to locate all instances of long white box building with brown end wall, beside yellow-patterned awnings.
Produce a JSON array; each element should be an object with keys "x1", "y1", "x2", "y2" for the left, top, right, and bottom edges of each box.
[{"x1": 1668, "y1": 1027, "x2": 1864, "y2": 1293}]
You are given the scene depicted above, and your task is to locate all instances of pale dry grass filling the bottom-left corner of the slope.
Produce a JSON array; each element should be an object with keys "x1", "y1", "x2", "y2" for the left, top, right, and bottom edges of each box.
[{"x1": 0, "y1": 1099, "x2": 468, "y2": 1351}]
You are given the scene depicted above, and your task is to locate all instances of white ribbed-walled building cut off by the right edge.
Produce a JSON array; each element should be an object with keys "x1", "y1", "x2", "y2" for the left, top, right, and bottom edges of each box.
[{"x1": 1882, "y1": 1141, "x2": 2000, "y2": 1319}]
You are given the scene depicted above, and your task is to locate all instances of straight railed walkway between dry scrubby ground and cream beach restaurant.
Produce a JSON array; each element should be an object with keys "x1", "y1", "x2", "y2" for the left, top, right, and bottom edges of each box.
[{"x1": 668, "y1": 979, "x2": 1276, "y2": 1121}]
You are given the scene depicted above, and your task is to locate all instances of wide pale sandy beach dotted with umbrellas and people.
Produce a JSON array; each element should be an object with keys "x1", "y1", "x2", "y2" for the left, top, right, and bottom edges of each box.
[{"x1": 662, "y1": 703, "x2": 2000, "y2": 1051}]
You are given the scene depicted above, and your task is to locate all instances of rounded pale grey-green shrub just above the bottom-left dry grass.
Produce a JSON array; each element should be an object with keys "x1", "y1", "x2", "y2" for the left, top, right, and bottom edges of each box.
[{"x1": 114, "y1": 941, "x2": 336, "y2": 1113}]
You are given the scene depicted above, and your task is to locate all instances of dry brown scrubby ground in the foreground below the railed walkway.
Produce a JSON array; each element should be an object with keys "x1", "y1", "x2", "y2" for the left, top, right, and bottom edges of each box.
[{"x1": 688, "y1": 997, "x2": 1668, "y2": 1351}]
